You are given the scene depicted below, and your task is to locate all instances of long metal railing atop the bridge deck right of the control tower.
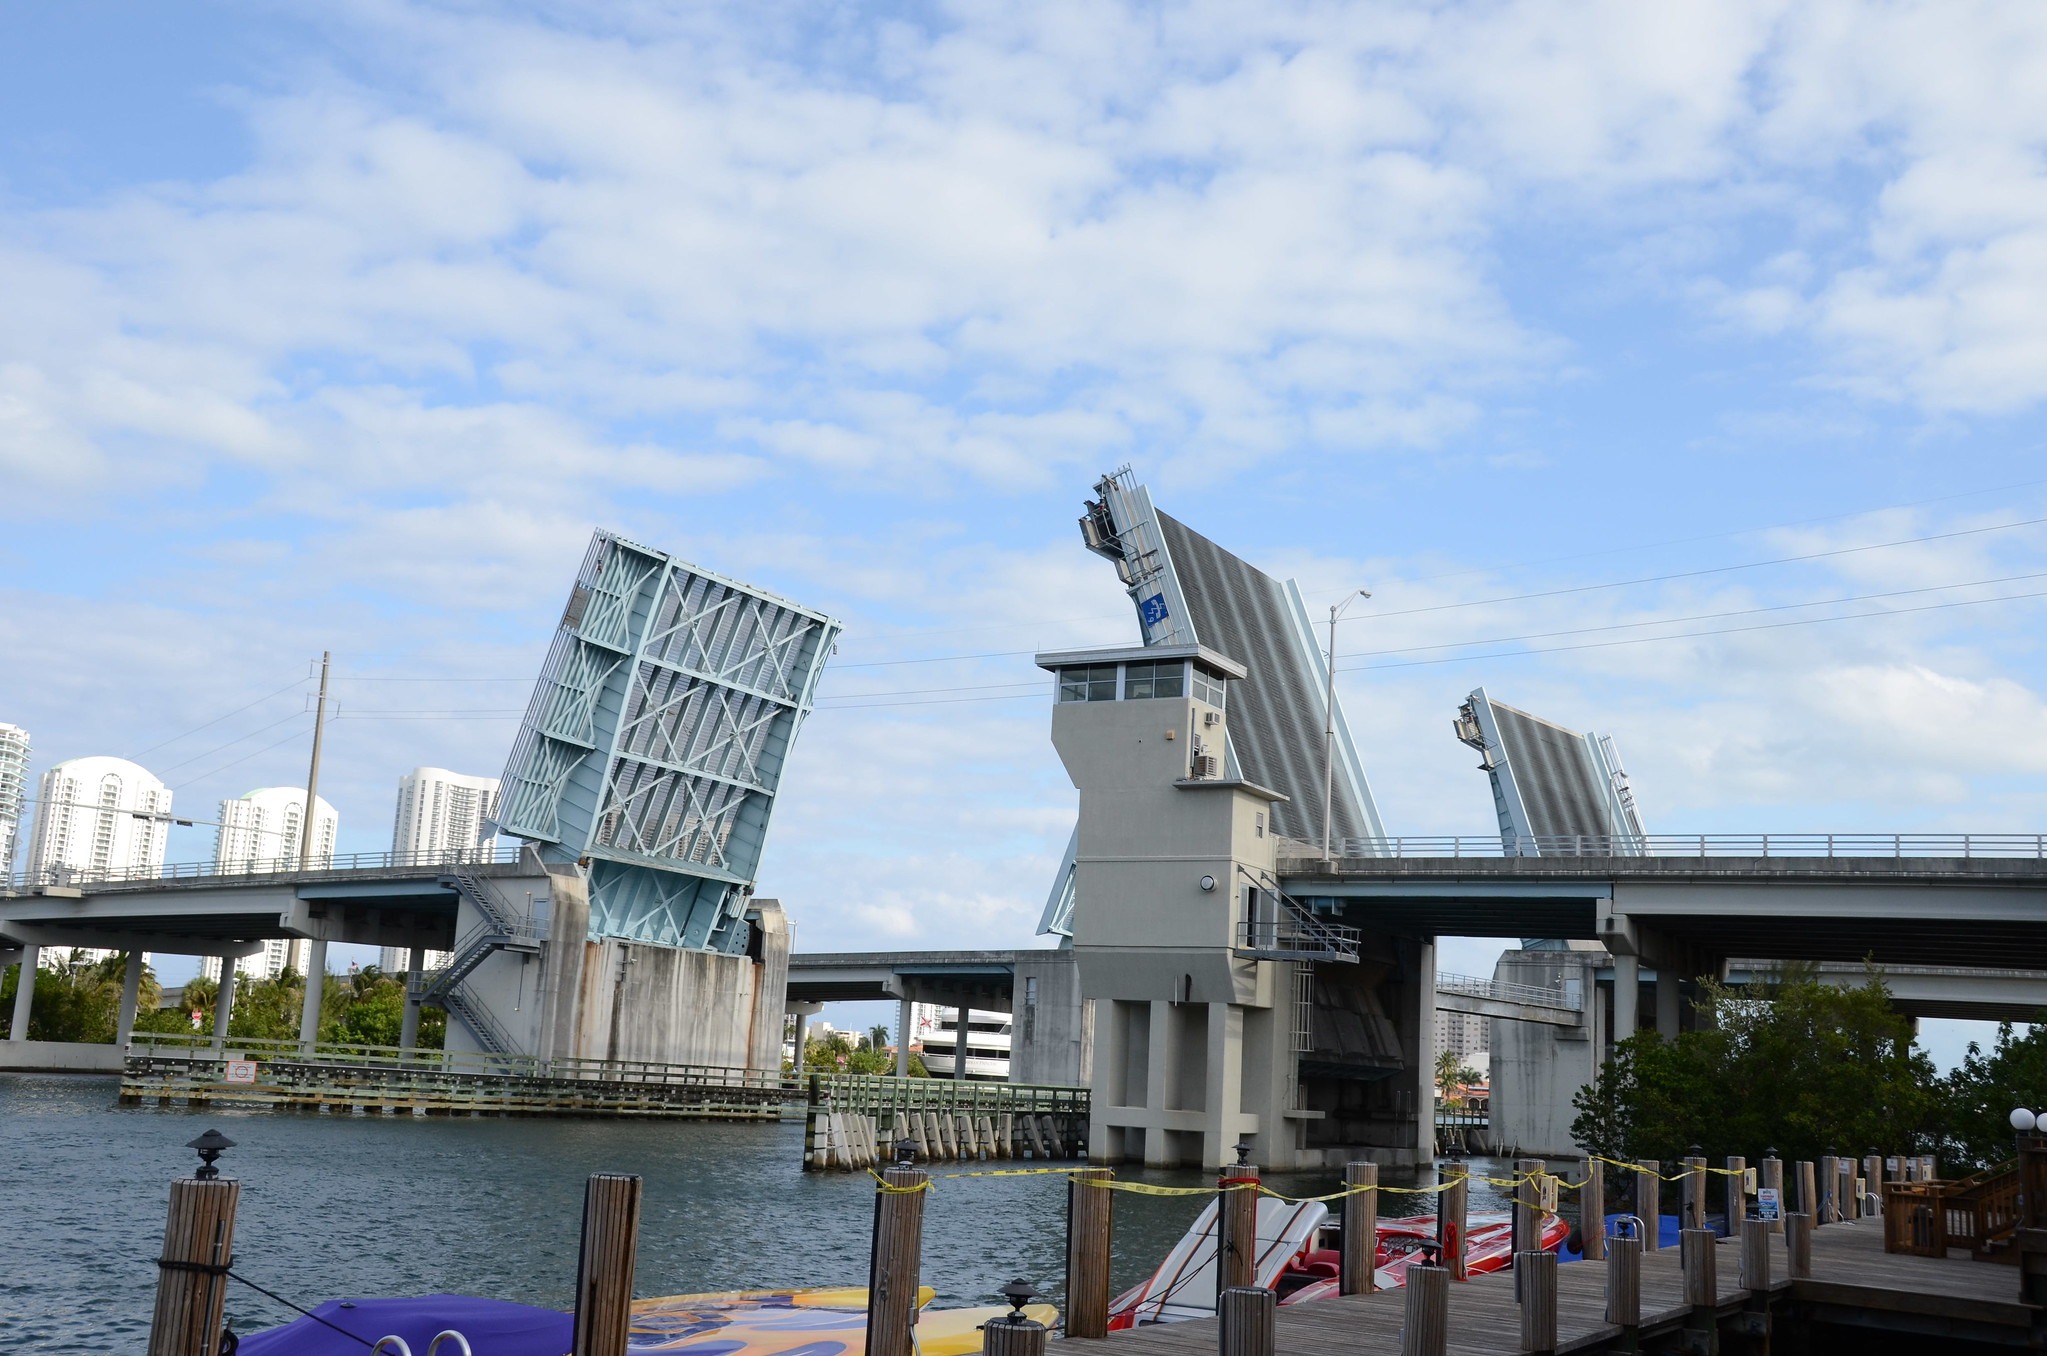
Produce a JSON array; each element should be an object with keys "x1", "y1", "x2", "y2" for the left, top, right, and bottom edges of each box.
[{"x1": 1279, "y1": 834, "x2": 2047, "y2": 868}]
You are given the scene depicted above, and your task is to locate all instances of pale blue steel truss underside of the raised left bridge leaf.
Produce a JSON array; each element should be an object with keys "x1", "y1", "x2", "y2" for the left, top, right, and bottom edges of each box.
[{"x1": 499, "y1": 533, "x2": 839, "y2": 952}]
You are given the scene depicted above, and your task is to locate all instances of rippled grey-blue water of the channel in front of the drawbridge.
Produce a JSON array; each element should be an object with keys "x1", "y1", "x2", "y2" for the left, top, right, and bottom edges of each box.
[{"x1": 0, "y1": 1075, "x2": 1522, "y2": 1356}]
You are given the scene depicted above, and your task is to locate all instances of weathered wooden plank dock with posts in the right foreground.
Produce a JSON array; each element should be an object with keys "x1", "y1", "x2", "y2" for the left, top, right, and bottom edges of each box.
[{"x1": 1058, "y1": 1219, "x2": 2039, "y2": 1356}]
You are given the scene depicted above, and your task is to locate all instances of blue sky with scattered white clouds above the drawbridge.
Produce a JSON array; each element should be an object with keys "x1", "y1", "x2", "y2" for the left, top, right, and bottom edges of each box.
[{"x1": 0, "y1": 0, "x2": 2047, "y2": 1081}]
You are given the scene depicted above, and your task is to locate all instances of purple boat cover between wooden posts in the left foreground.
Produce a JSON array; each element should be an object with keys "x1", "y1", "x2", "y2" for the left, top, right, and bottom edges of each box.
[{"x1": 239, "y1": 1295, "x2": 575, "y2": 1356}]
